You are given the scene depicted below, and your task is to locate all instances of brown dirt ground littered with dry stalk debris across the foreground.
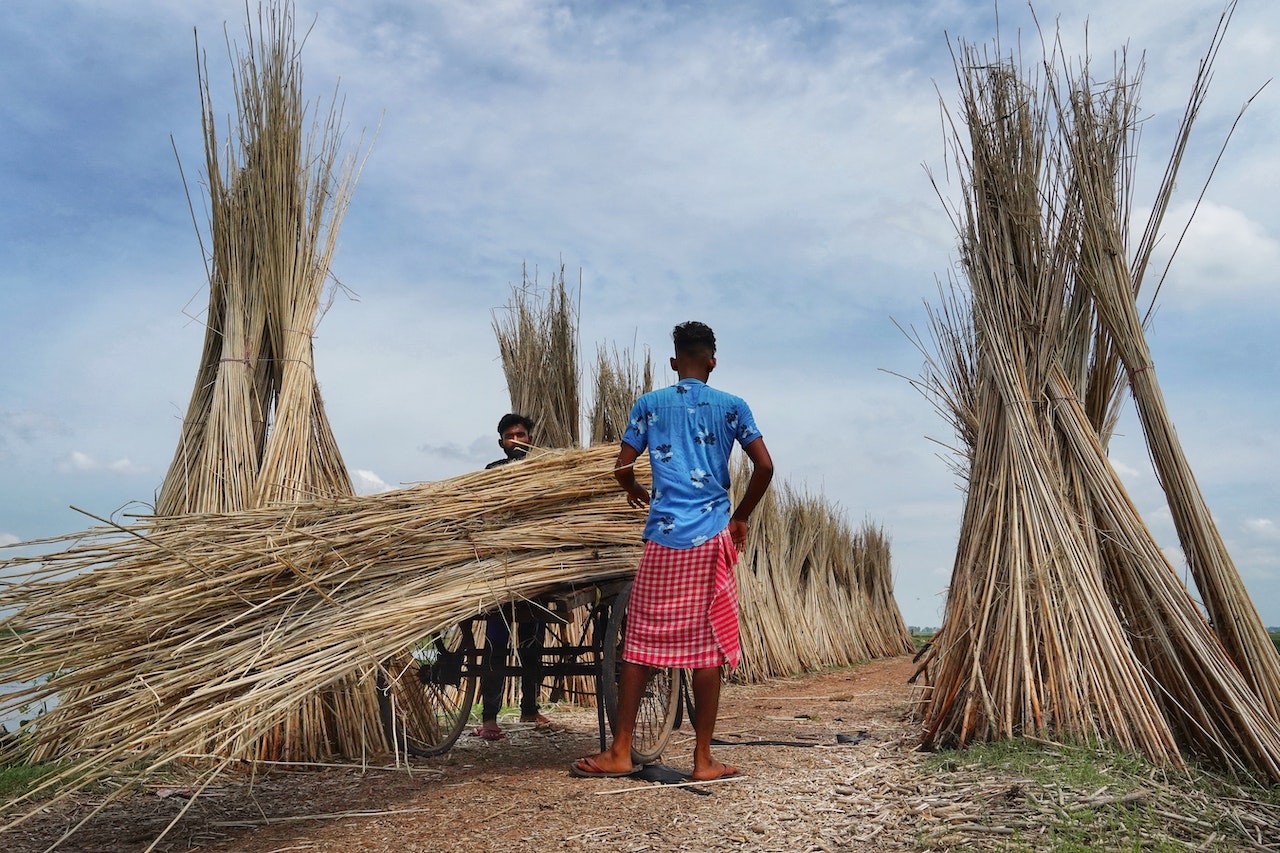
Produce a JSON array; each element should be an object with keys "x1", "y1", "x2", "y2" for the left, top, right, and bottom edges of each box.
[{"x1": 0, "y1": 657, "x2": 1280, "y2": 853}]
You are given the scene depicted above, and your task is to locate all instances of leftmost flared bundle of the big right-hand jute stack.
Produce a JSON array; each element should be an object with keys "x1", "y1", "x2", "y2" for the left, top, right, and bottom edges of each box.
[{"x1": 925, "y1": 55, "x2": 1176, "y2": 758}]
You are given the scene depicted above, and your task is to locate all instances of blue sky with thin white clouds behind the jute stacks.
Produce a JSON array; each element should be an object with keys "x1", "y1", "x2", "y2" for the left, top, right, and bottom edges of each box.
[{"x1": 0, "y1": 0, "x2": 1280, "y2": 625}]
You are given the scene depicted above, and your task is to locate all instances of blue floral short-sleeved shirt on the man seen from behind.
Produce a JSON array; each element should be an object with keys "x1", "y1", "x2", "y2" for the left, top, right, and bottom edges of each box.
[{"x1": 622, "y1": 379, "x2": 760, "y2": 549}]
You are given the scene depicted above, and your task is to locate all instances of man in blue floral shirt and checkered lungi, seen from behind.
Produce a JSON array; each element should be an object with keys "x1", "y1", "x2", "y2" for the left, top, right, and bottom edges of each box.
[{"x1": 571, "y1": 321, "x2": 773, "y2": 781}]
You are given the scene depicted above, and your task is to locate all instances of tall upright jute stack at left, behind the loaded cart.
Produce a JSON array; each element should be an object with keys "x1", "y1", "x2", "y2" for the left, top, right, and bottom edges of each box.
[{"x1": 156, "y1": 4, "x2": 378, "y2": 758}]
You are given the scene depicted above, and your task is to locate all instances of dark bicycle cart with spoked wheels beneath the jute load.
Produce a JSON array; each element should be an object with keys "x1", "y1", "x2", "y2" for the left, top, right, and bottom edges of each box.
[{"x1": 378, "y1": 578, "x2": 682, "y2": 763}]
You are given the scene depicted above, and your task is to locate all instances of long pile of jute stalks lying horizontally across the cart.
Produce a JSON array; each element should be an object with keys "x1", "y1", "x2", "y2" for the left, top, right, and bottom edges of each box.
[{"x1": 0, "y1": 447, "x2": 644, "y2": 824}]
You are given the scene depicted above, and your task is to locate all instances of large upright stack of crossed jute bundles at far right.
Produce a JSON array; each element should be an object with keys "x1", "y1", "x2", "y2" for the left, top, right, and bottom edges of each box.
[{"x1": 922, "y1": 6, "x2": 1280, "y2": 779}]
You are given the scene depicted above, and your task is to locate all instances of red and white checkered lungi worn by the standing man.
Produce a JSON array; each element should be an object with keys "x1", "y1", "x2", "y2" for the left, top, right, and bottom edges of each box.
[{"x1": 622, "y1": 528, "x2": 740, "y2": 669}]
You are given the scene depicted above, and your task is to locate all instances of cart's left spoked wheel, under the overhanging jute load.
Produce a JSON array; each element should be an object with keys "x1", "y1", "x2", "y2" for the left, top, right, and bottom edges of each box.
[{"x1": 378, "y1": 622, "x2": 476, "y2": 757}]
